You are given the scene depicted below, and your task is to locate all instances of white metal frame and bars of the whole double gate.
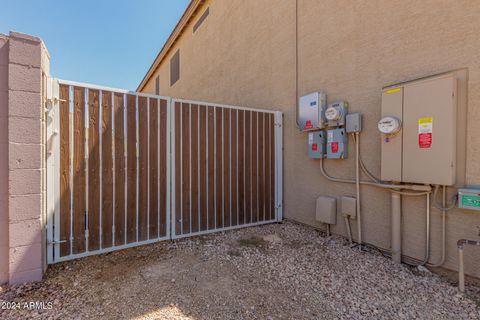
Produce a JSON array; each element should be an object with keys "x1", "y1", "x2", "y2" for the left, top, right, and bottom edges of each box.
[{"x1": 45, "y1": 78, "x2": 283, "y2": 264}]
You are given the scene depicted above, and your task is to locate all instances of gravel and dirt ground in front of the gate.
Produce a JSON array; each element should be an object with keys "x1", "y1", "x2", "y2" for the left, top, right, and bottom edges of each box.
[{"x1": 0, "y1": 222, "x2": 480, "y2": 319}]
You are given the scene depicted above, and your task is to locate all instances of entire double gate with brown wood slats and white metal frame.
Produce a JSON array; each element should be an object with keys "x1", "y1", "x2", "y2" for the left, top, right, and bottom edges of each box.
[{"x1": 47, "y1": 79, "x2": 282, "y2": 263}]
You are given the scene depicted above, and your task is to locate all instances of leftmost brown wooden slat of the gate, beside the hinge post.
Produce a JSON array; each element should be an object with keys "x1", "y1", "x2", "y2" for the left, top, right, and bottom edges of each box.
[{"x1": 59, "y1": 85, "x2": 72, "y2": 256}]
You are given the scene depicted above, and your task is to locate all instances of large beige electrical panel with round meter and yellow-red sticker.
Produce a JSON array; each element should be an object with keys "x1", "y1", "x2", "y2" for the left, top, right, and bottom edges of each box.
[{"x1": 378, "y1": 74, "x2": 457, "y2": 185}]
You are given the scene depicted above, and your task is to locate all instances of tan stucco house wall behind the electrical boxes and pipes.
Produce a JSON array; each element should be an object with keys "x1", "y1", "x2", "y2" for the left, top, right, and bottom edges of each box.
[{"x1": 144, "y1": 0, "x2": 480, "y2": 277}]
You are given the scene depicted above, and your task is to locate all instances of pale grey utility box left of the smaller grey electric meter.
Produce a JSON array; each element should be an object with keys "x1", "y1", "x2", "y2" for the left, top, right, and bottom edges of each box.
[{"x1": 298, "y1": 92, "x2": 327, "y2": 131}]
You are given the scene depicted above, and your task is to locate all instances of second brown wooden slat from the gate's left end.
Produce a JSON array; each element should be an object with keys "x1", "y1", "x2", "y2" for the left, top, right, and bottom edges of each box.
[{"x1": 72, "y1": 87, "x2": 86, "y2": 254}]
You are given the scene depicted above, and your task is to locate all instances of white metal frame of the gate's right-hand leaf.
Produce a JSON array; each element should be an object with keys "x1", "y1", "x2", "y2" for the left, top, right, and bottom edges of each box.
[{"x1": 170, "y1": 98, "x2": 283, "y2": 239}]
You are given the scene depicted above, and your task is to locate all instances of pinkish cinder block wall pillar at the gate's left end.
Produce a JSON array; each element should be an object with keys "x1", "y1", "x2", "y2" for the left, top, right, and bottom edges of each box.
[{"x1": 0, "y1": 32, "x2": 49, "y2": 284}]
